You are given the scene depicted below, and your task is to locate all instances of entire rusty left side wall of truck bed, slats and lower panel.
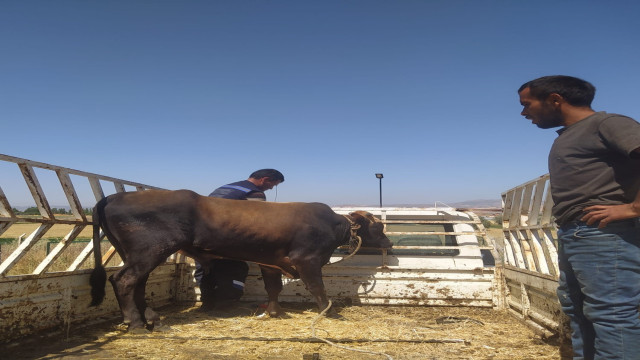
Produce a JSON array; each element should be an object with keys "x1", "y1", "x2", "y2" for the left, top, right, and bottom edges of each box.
[{"x1": 0, "y1": 154, "x2": 189, "y2": 341}]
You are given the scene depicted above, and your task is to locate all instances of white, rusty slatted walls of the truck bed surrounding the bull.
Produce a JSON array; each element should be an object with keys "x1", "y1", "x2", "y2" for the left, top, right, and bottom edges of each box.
[{"x1": 0, "y1": 154, "x2": 566, "y2": 358}]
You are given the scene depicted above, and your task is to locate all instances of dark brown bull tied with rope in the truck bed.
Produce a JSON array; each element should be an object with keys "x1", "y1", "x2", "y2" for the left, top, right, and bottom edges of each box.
[{"x1": 91, "y1": 190, "x2": 391, "y2": 330}]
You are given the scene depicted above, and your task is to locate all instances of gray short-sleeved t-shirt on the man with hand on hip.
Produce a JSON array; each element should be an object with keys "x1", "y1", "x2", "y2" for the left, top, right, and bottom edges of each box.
[{"x1": 549, "y1": 112, "x2": 640, "y2": 225}]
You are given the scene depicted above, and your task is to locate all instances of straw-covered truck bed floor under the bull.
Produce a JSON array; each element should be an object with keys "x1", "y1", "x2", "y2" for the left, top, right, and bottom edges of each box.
[{"x1": 0, "y1": 303, "x2": 561, "y2": 360}]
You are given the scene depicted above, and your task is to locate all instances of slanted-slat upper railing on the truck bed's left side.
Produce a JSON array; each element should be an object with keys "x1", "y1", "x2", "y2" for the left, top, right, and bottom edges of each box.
[{"x1": 0, "y1": 154, "x2": 164, "y2": 278}]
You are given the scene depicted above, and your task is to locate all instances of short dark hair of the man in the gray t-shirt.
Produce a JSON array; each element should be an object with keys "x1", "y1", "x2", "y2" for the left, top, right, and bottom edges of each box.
[{"x1": 518, "y1": 75, "x2": 596, "y2": 107}]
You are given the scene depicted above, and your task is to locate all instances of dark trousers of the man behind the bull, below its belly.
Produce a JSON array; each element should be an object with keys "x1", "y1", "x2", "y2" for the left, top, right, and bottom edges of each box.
[{"x1": 195, "y1": 259, "x2": 249, "y2": 306}]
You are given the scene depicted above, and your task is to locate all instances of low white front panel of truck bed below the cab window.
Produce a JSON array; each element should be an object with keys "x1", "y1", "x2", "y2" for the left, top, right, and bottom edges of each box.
[{"x1": 243, "y1": 262, "x2": 495, "y2": 307}]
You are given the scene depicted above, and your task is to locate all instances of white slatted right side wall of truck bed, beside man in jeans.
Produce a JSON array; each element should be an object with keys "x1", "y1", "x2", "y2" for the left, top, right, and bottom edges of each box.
[{"x1": 502, "y1": 174, "x2": 565, "y2": 333}]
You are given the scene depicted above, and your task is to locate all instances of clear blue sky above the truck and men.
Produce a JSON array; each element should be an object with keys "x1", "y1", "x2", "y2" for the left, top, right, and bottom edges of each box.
[{"x1": 0, "y1": 0, "x2": 640, "y2": 205}]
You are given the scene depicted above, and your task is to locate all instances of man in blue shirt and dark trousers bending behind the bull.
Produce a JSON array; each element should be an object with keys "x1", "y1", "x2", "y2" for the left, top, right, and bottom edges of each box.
[{"x1": 195, "y1": 169, "x2": 284, "y2": 310}]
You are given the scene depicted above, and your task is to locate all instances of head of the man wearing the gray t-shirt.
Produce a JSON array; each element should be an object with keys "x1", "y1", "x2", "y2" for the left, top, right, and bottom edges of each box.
[{"x1": 518, "y1": 75, "x2": 596, "y2": 129}]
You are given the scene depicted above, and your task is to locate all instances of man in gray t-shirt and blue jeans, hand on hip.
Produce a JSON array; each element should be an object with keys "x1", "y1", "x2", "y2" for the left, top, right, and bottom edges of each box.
[{"x1": 518, "y1": 76, "x2": 640, "y2": 359}]
